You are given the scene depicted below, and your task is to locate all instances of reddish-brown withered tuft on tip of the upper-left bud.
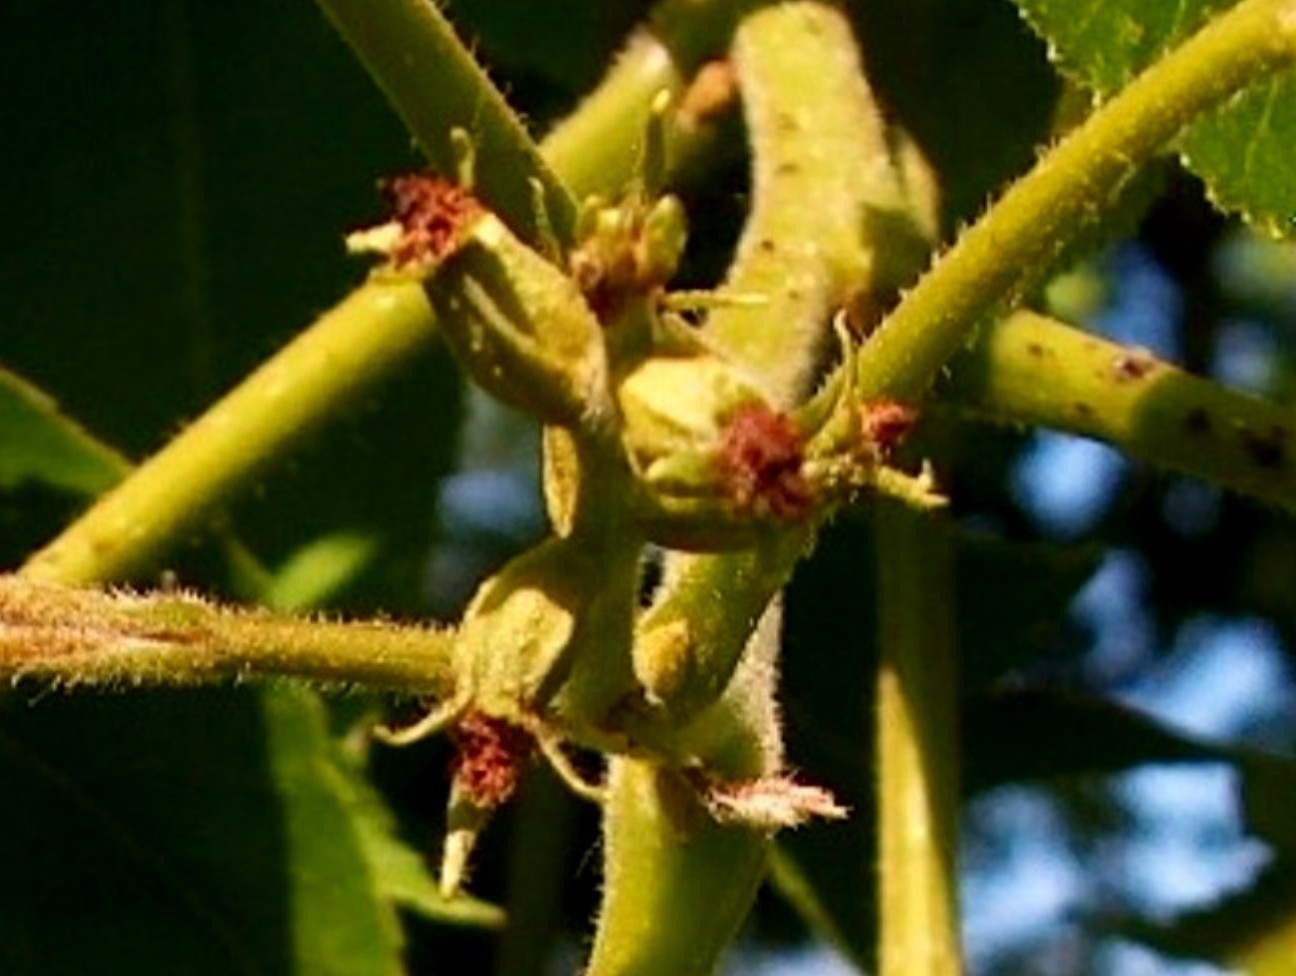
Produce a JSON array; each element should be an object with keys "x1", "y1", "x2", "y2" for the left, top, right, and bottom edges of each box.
[{"x1": 378, "y1": 174, "x2": 483, "y2": 267}]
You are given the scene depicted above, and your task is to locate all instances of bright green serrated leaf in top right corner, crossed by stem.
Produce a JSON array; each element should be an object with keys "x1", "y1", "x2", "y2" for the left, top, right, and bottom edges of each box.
[{"x1": 1015, "y1": 0, "x2": 1296, "y2": 236}]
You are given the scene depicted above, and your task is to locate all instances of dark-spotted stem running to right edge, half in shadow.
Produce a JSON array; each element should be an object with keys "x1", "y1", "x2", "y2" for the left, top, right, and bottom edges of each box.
[{"x1": 946, "y1": 311, "x2": 1296, "y2": 511}]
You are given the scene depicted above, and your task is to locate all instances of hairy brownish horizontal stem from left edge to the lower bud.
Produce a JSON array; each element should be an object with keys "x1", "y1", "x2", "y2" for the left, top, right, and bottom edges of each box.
[{"x1": 0, "y1": 575, "x2": 455, "y2": 699}]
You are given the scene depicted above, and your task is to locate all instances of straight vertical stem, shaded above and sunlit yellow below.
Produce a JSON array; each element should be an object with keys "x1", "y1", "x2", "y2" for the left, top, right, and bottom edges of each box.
[{"x1": 875, "y1": 504, "x2": 962, "y2": 976}]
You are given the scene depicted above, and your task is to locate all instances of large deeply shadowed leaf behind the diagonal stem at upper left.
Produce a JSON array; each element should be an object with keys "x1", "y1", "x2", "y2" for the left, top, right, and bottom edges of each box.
[{"x1": 0, "y1": 0, "x2": 459, "y2": 612}]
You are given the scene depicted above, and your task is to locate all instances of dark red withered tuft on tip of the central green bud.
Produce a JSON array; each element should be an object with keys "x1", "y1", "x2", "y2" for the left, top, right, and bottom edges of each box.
[{"x1": 719, "y1": 404, "x2": 813, "y2": 520}]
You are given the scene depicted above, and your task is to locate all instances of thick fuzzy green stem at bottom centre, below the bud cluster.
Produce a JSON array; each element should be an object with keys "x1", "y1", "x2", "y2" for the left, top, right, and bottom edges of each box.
[{"x1": 586, "y1": 601, "x2": 783, "y2": 976}]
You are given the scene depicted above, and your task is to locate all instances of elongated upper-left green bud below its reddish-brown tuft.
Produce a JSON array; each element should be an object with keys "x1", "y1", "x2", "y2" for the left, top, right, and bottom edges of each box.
[{"x1": 426, "y1": 215, "x2": 607, "y2": 426}]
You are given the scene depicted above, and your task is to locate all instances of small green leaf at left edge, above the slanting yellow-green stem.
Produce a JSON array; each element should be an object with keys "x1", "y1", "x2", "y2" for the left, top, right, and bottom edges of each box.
[{"x1": 0, "y1": 367, "x2": 130, "y2": 498}]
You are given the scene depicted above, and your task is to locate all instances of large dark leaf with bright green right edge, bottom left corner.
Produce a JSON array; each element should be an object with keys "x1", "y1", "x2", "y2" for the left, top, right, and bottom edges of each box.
[{"x1": 0, "y1": 686, "x2": 400, "y2": 976}]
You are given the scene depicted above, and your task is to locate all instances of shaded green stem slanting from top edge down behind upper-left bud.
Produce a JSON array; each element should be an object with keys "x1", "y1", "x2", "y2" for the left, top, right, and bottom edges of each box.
[{"x1": 311, "y1": 0, "x2": 575, "y2": 246}]
